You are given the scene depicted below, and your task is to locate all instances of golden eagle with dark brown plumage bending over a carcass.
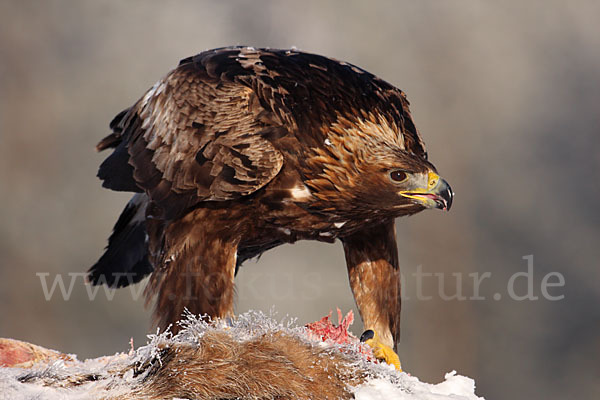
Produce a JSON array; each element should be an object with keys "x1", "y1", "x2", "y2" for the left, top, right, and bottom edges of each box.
[{"x1": 89, "y1": 47, "x2": 452, "y2": 345}]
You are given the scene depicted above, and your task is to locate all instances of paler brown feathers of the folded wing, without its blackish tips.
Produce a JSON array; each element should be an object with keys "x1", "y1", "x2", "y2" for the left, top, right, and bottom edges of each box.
[{"x1": 123, "y1": 63, "x2": 283, "y2": 206}]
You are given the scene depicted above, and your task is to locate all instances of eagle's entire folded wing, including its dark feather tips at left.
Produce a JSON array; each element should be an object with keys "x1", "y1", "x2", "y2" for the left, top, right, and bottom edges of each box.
[{"x1": 98, "y1": 54, "x2": 284, "y2": 217}]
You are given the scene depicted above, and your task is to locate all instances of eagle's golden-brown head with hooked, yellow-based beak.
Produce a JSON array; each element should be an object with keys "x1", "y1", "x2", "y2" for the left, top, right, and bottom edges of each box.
[{"x1": 305, "y1": 112, "x2": 454, "y2": 218}]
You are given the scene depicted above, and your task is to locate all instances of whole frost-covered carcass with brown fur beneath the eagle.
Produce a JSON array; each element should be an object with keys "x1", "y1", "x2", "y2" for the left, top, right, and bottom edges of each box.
[{"x1": 0, "y1": 312, "x2": 476, "y2": 400}]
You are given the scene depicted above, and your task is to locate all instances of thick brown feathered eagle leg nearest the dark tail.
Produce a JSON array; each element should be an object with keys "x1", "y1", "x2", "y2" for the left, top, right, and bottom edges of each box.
[{"x1": 146, "y1": 209, "x2": 239, "y2": 332}]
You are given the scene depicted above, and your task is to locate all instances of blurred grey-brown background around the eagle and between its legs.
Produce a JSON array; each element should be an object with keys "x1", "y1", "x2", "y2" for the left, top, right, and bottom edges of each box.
[{"x1": 0, "y1": 0, "x2": 600, "y2": 399}]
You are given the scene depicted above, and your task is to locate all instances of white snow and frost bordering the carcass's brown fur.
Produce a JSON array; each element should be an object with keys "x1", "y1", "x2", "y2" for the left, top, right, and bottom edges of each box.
[{"x1": 0, "y1": 311, "x2": 481, "y2": 400}]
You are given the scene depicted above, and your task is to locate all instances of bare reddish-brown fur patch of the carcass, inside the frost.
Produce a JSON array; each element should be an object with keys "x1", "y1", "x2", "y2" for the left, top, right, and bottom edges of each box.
[{"x1": 124, "y1": 332, "x2": 362, "y2": 400}]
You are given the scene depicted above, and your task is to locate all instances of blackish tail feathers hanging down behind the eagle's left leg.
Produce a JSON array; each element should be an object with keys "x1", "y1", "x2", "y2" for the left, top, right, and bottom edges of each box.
[{"x1": 88, "y1": 194, "x2": 154, "y2": 288}]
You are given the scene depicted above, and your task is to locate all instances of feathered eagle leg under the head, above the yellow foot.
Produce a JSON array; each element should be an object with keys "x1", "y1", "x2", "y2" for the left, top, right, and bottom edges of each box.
[{"x1": 342, "y1": 220, "x2": 401, "y2": 368}]
